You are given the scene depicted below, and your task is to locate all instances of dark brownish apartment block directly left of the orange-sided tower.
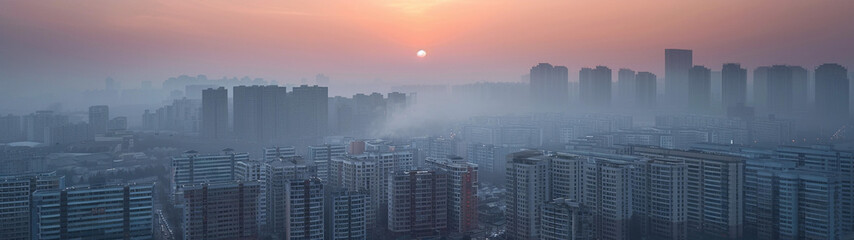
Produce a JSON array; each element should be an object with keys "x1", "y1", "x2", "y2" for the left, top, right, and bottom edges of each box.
[{"x1": 387, "y1": 170, "x2": 451, "y2": 239}]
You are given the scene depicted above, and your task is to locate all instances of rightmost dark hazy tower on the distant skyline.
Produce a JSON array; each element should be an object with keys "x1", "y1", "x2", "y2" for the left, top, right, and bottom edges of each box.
[{"x1": 815, "y1": 63, "x2": 850, "y2": 123}]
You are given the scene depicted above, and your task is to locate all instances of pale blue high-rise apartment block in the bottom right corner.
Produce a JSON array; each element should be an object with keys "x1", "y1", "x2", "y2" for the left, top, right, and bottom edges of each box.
[{"x1": 756, "y1": 170, "x2": 854, "y2": 239}]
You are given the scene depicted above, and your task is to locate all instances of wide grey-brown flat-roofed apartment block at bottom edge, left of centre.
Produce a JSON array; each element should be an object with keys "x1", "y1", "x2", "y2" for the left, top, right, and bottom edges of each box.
[{"x1": 181, "y1": 182, "x2": 260, "y2": 240}]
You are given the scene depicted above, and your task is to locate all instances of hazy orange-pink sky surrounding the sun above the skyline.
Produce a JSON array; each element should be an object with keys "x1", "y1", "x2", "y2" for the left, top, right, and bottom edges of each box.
[{"x1": 0, "y1": 0, "x2": 854, "y2": 91}]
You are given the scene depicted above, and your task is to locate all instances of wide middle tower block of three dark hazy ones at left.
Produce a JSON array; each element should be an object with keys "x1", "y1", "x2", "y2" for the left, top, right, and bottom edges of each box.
[{"x1": 234, "y1": 86, "x2": 288, "y2": 143}]
